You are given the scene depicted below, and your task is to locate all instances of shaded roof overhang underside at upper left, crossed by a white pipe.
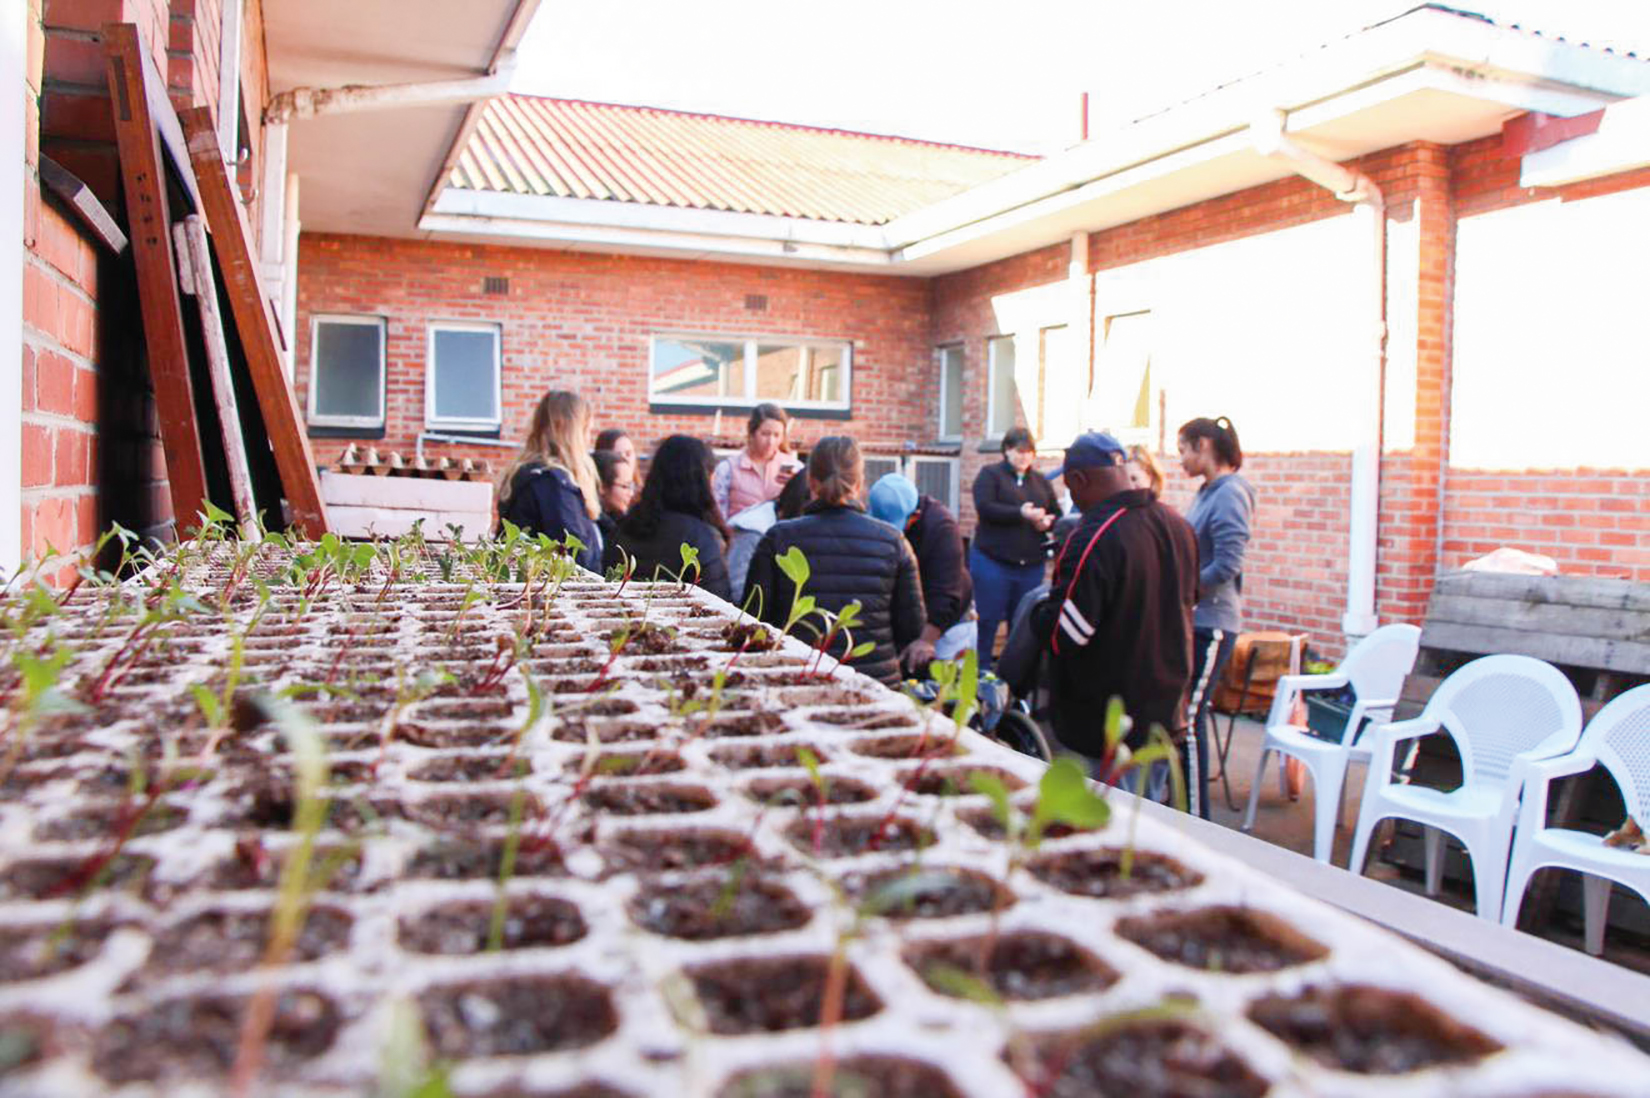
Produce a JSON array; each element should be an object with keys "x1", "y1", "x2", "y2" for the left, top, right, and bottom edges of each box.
[{"x1": 264, "y1": 0, "x2": 540, "y2": 236}]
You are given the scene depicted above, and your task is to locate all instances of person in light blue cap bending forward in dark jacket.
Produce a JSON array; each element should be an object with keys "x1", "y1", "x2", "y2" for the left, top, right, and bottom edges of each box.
[{"x1": 870, "y1": 472, "x2": 974, "y2": 670}]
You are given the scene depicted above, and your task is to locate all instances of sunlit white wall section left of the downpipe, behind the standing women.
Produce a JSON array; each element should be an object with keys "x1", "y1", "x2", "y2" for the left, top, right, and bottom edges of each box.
[{"x1": 1084, "y1": 216, "x2": 1376, "y2": 452}]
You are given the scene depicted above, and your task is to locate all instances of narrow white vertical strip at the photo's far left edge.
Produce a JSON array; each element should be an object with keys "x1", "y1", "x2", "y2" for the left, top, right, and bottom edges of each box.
[{"x1": 0, "y1": 3, "x2": 33, "y2": 576}]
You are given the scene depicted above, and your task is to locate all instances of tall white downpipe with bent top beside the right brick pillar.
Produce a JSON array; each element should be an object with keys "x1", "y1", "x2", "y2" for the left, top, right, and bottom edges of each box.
[{"x1": 1249, "y1": 111, "x2": 1386, "y2": 637}]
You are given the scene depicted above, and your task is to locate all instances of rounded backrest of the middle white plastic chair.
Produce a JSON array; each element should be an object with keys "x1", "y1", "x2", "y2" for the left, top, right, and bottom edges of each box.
[{"x1": 1424, "y1": 655, "x2": 1581, "y2": 786}]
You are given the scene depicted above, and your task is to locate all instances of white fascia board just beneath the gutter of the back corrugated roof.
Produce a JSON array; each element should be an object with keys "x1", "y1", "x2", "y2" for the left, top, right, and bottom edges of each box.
[{"x1": 417, "y1": 213, "x2": 903, "y2": 274}]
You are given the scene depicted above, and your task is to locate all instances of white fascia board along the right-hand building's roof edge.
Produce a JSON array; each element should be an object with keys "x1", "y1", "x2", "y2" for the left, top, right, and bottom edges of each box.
[{"x1": 884, "y1": 10, "x2": 1650, "y2": 251}]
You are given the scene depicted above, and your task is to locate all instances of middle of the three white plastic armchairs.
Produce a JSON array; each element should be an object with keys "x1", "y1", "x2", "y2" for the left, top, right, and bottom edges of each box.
[{"x1": 1350, "y1": 655, "x2": 1581, "y2": 920}]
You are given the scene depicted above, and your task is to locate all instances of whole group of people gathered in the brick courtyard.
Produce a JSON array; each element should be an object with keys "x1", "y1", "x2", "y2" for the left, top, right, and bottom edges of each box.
[{"x1": 498, "y1": 384, "x2": 1254, "y2": 816}]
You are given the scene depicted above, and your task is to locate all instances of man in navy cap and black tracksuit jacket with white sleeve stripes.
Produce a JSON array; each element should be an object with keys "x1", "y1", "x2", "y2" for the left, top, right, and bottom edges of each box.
[{"x1": 1033, "y1": 431, "x2": 1198, "y2": 758}]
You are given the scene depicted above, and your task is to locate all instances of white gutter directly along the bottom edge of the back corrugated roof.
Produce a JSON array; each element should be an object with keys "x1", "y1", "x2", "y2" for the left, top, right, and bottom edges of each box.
[{"x1": 431, "y1": 187, "x2": 888, "y2": 253}]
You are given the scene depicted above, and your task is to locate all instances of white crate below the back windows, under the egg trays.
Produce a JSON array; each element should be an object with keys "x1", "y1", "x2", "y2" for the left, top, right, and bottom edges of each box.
[{"x1": 320, "y1": 469, "x2": 493, "y2": 542}]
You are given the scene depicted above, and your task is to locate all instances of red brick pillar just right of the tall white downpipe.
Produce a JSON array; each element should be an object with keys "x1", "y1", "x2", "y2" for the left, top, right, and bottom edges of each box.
[{"x1": 1376, "y1": 144, "x2": 1455, "y2": 624}]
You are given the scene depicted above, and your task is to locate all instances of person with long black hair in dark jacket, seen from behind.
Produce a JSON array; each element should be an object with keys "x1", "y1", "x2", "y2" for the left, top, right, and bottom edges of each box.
[{"x1": 602, "y1": 434, "x2": 731, "y2": 599}]
